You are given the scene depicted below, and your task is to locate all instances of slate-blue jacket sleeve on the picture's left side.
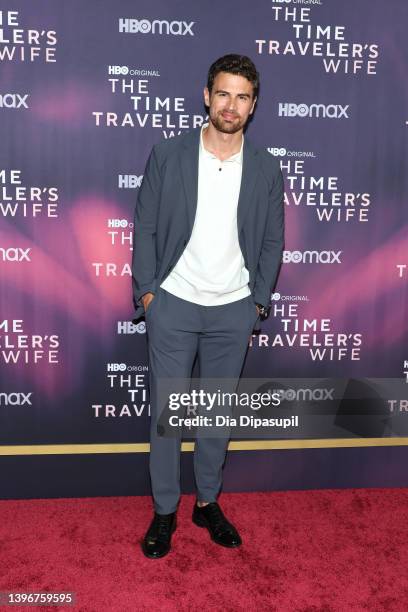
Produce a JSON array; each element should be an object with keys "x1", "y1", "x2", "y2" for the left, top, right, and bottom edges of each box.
[{"x1": 132, "y1": 147, "x2": 161, "y2": 308}]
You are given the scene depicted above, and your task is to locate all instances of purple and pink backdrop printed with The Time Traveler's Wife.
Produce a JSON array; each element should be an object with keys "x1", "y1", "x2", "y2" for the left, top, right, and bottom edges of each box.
[{"x1": 0, "y1": 0, "x2": 408, "y2": 492}]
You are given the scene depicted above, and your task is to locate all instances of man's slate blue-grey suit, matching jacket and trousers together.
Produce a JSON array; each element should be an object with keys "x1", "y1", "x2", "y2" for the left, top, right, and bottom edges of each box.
[{"x1": 132, "y1": 129, "x2": 283, "y2": 514}]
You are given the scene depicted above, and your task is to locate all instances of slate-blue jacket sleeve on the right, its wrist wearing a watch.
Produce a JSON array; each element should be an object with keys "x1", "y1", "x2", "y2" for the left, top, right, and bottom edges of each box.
[{"x1": 254, "y1": 167, "x2": 285, "y2": 306}]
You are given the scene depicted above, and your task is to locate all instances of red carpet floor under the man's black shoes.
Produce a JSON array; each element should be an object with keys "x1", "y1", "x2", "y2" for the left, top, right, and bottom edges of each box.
[{"x1": 0, "y1": 489, "x2": 408, "y2": 612}]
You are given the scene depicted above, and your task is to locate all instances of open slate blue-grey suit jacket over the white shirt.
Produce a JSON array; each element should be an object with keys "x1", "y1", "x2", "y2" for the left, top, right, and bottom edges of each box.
[{"x1": 132, "y1": 128, "x2": 284, "y2": 330}]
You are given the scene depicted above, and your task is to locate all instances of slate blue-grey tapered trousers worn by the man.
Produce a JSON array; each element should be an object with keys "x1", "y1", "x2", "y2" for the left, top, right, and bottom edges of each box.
[{"x1": 146, "y1": 287, "x2": 258, "y2": 514}]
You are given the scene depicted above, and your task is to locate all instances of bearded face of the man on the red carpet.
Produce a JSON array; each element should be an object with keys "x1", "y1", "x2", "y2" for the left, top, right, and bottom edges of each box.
[{"x1": 204, "y1": 72, "x2": 256, "y2": 134}]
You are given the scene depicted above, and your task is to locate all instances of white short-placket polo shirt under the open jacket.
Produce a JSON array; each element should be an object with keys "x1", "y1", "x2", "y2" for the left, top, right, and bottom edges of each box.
[{"x1": 161, "y1": 123, "x2": 251, "y2": 306}]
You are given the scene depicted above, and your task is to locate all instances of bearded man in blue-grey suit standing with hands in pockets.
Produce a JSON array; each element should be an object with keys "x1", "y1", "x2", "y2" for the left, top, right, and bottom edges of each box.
[{"x1": 133, "y1": 54, "x2": 284, "y2": 558}]
